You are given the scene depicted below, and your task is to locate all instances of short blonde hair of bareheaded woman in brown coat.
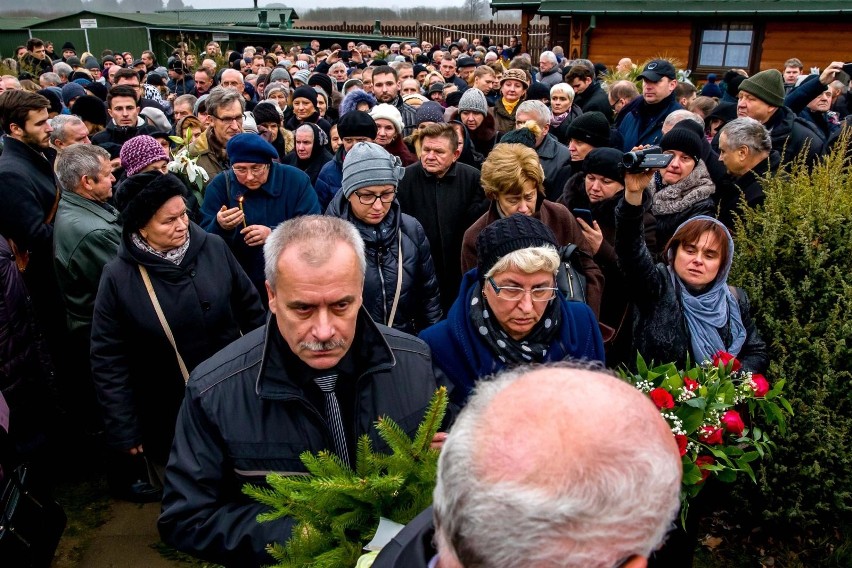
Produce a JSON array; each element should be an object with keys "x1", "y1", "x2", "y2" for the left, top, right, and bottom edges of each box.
[{"x1": 480, "y1": 142, "x2": 544, "y2": 200}]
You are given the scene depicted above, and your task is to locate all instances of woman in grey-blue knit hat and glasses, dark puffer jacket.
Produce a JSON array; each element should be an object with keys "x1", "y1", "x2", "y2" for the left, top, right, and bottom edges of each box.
[{"x1": 326, "y1": 142, "x2": 443, "y2": 333}]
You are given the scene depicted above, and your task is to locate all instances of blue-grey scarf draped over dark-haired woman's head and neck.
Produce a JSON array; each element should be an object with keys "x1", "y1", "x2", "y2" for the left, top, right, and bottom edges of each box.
[{"x1": 668, "y1": 215, "x2": 746, "y2": 363}]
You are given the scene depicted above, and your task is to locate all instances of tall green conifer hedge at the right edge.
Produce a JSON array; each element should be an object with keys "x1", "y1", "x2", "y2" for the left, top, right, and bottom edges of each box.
[{"x1": 732, "y1": 133, "x2": 852, "y2": 565}]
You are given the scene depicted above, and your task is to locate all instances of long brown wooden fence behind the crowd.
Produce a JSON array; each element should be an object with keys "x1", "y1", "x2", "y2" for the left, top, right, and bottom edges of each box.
[{"x1": 297, "y1": 22, "x2": 550, "y2": 58}]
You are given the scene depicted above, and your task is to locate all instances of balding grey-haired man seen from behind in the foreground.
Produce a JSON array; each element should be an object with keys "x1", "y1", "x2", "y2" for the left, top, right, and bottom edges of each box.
[{"x1": 373, "y1": 364, "x2": 682, "y2": 568}]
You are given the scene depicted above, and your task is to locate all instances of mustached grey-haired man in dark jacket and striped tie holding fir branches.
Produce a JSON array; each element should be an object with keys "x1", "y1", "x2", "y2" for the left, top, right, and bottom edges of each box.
[{"x1": 159, "y1": 216, "x2": 447, "y2": 568}]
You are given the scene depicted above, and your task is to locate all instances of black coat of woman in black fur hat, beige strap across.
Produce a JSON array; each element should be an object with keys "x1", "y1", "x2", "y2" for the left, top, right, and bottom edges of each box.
[{"x1": 92, "y1": 224, "x2": 265, "y2": 459}]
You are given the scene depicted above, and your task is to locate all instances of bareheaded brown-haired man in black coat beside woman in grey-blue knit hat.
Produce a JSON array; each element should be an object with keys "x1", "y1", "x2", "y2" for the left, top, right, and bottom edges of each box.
[{"x1": 397, "y1": 124, "x2": 488, "y2": 314}]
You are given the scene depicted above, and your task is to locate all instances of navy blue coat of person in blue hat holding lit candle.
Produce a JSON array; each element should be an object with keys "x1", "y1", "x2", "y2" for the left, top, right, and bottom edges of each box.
[{"x1": 201, "y1": 164, "x2": 322, "y2": 296}]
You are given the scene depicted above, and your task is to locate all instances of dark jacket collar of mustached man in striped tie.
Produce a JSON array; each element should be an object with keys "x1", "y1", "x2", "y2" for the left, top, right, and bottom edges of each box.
[{"x1": 255, "y1": 305, "x2": 396, "y2": 400}]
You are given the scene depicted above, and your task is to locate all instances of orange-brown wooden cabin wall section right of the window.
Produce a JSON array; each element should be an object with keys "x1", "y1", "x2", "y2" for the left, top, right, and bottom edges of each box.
[{"x1": 760, "y1": 20, "x2": 852, "y2": 73}]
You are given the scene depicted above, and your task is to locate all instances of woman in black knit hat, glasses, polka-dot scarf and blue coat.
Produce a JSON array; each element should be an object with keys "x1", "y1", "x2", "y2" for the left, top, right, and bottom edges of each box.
[{"x1": 420, "y1": 213, "x2": 604, "y2": 404}]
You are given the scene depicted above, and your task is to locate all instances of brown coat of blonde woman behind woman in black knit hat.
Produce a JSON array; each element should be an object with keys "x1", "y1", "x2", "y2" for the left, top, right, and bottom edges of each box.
[{"x1": 461, "y1": 200, "x2": 604, "y2": 315}]
